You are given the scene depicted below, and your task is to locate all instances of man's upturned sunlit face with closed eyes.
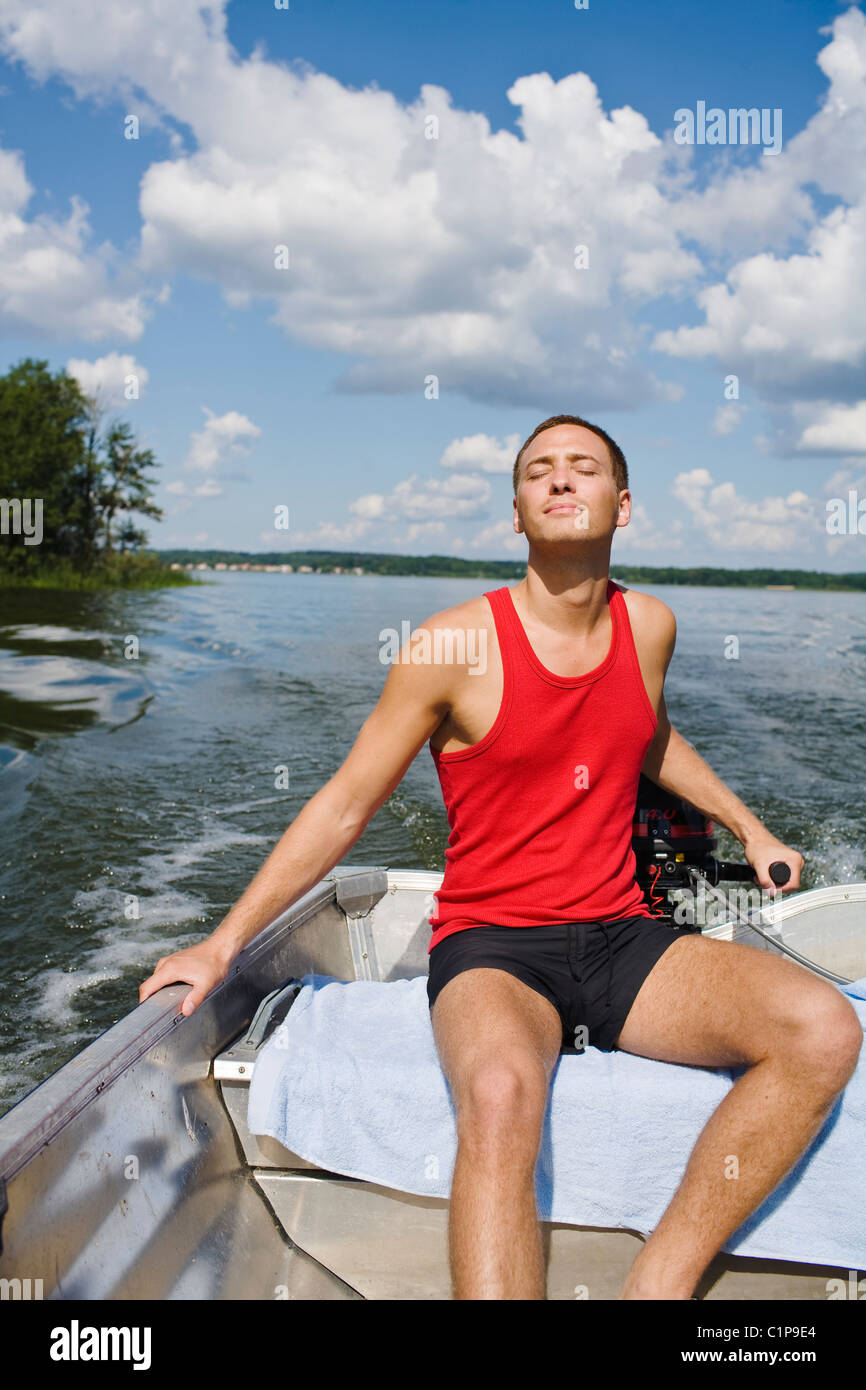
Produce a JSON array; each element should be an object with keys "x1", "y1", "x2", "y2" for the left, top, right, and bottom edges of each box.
[{"x1": 514, "y1": 425, "x2": 631, "y2": 541}]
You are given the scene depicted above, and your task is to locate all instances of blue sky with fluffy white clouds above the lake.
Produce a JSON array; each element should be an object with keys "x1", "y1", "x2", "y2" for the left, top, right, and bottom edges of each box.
[{"x1": 0, "y1": 0, "x2": 866, "y2": 571}]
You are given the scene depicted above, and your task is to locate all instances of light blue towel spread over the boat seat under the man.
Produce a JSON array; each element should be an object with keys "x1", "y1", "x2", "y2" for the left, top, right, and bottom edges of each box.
[{"x1": 247, "y1": 974, "x2": 866, "y2": 1269}]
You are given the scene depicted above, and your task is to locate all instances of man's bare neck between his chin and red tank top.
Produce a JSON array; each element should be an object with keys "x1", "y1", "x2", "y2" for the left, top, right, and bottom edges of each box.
[{"x1": 512, "y1": 548, "x2": 610, "y2": 638}]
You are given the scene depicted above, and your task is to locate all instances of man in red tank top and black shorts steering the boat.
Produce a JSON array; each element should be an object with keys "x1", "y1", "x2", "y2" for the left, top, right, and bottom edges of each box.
[{"x1": 139, "y1": 416, "x2": 863, "y2": 1300}]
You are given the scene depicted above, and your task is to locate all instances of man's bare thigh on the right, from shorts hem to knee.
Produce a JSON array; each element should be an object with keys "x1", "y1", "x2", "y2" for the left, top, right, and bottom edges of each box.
[{"x1": 616, "y1": 933, "x2": 859, "y2": 1066}]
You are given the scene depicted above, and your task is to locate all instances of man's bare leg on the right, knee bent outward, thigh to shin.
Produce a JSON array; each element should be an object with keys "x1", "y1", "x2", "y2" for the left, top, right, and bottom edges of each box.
[{"x1": 617, "y1": 935, "x2": 863, "y2": 1298}]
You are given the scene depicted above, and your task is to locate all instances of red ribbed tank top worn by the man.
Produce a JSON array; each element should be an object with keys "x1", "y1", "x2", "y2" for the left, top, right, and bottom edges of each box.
[{"x1": 428, "y1": 580, "x2": 657, "y2": 952}]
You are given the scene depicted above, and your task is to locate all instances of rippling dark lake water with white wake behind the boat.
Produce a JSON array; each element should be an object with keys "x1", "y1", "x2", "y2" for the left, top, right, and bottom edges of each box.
[{"x1": 0, "y1": 566, "x2": 866, "y2": 1113}]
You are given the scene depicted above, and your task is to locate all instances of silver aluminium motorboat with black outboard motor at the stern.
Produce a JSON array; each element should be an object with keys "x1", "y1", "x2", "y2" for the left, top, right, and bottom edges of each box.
[{"x1": 0, "y1": 778, "x2": 866, "y2": 1301}]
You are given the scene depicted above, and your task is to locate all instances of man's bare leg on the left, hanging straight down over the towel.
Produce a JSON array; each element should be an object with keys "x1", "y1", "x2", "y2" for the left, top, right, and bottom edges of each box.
[{"x1": 431, "y1": 967, "x2": 562, "y2": 1300}]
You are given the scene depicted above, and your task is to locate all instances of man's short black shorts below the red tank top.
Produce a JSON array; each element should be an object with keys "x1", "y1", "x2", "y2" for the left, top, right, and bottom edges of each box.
[{"x1": 427, "y1": 917, "x2": 701, "y2": 1052}]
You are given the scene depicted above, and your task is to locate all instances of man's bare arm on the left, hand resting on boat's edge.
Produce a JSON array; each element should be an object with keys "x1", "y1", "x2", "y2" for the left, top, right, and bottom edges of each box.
[{"x1": 139, "y1": 624, "x2": 453, "y2": 1015}]
